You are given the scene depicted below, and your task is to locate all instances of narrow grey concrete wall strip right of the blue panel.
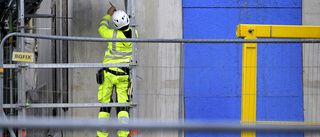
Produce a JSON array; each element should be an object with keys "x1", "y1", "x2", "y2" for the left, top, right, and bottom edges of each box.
[{"x1": 302, "y1": 0, "x2": 320, "y2": 137}]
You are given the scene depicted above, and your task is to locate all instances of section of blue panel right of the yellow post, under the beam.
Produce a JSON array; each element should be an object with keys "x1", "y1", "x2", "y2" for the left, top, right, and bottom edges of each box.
[{"x1": 257, "y1": 44, "x2": 304, "y2": 137}]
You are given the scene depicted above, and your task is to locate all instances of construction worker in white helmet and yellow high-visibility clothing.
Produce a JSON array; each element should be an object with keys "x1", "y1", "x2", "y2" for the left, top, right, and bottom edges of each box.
[{"x1": 97, "y1": 6, "x2": 138, "y2": 137}]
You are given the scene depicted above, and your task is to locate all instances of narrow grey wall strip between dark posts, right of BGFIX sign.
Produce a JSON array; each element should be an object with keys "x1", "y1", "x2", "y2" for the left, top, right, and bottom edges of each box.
[{"x1": 26, "y1": 0, "x2": 53, "y2": 137}]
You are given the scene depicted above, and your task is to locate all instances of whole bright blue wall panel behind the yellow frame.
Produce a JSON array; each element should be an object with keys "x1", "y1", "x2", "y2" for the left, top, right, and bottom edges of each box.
[{"x1": 183, "y1": 0, "x2": 303, "y2": 137}]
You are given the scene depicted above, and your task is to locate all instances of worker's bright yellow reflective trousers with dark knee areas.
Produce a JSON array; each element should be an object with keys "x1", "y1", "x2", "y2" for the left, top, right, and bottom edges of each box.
[{"x1": 97, "y1": 71, "x2": 130, "y2": 137}]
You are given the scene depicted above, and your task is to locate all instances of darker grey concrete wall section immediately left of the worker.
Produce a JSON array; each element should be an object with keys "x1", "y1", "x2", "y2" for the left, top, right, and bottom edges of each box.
[{"x1": 69, "y1": 0, "x2": 111, "y2": 137}]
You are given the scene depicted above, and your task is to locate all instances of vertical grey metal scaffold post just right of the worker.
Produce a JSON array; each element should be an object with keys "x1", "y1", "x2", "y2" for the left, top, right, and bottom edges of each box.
[{"x1": 131, "y1": 0, "x2": 138, "y2": 137}]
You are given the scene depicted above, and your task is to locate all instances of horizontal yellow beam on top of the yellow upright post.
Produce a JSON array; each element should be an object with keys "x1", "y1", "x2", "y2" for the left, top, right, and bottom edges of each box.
[{"x1": 236, "y1": 24, "x2": 320, "y2": 38}]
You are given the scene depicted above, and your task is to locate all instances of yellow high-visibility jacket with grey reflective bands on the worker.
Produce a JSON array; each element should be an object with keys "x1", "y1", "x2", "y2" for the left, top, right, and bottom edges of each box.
[{"x1": 99, "y1": 14, "x2": 138, "y2": 63}]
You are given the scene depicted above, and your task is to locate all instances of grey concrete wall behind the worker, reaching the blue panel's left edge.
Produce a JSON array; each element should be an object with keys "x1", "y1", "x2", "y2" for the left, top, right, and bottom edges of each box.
[{"x1": 69, "y1": 0, "x2": 182, "y2": 137}]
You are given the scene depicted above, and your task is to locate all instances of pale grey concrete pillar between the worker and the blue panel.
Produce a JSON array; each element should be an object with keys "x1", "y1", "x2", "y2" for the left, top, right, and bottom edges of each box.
[{"x1": 136, "y1": 0, "x2": 182, "y2": 137}]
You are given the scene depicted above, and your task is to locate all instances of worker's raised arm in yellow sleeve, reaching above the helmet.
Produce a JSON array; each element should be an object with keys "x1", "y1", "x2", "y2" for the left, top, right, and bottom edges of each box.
[{"x1": 98, "y1": 6, "x2": 116, "y2": 38}]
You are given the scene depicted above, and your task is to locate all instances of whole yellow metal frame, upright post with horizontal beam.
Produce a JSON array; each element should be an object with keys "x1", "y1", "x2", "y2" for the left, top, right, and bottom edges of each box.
[{"x1": 236, "y1": 24, "x2": 320, "y2": 137}]
